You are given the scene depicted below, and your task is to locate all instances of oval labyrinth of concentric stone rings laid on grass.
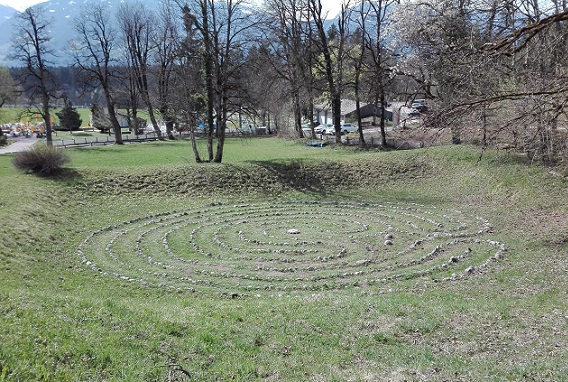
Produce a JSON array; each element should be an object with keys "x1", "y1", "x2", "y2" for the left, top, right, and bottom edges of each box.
[{"x1": 77, "y1": 201, "x2": 506, "y2": 297}]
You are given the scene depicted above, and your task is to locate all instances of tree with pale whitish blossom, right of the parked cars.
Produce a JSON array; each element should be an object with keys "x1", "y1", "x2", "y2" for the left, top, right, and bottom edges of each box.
[{"x1": 397, "y1": 0, "x2": 495, "y2": 144}]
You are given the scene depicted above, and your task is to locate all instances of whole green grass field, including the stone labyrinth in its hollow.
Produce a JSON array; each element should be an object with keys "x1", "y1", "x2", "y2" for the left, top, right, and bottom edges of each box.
[{"x1": 0, "y1": 138, "x2": 568, "y2": 381}]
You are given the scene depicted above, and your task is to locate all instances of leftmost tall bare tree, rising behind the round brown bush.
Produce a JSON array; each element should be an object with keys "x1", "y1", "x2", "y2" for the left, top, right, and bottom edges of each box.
[{"x1": 11, "y1": 7, "x2": 57, "y2": 145}]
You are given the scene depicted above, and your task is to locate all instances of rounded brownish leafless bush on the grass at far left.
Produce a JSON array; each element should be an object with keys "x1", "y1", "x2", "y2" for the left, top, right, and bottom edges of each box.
[{"x1": 13, "y1": 144, "x2": 69, "y2": 176}]
